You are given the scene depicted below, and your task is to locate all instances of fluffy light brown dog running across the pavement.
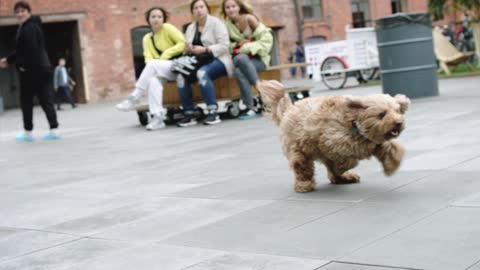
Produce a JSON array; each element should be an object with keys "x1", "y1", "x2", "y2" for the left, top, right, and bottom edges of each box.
[{"x1": 257, "y1": 81, "x2": 410, "y2": 192}]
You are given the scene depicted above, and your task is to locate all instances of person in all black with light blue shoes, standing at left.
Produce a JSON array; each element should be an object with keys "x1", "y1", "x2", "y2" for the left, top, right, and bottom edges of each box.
[{"x1": 0, "y1": 1, "x2": 60, "y2": 141}]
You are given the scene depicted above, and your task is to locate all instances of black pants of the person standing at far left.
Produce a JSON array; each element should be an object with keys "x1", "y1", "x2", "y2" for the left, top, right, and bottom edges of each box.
[{"x1": 20, "y1": 70, "x2": 58, "y2": 131}]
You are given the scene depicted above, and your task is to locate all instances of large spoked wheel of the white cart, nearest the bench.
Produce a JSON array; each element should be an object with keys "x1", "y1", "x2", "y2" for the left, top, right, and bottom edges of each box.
[{"x1": 320, "y1": 56, "x2": 347, "y2": 89}]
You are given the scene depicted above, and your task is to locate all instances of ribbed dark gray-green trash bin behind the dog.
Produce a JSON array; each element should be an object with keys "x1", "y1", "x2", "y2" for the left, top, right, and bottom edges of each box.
[{"x1": 375, "y1": 13, "x2": 438, "y2": 98}]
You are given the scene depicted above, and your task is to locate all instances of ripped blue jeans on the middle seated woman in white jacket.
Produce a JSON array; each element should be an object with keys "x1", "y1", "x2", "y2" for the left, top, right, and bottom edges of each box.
[{"x1": 177, "y1": 59, "x2": 227, "y2": 114}]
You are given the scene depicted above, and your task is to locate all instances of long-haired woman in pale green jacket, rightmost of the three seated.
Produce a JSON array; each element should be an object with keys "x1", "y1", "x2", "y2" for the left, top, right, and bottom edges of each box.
[{"x1": 221, "y1": 0, "x2": 273, "y2": 120}]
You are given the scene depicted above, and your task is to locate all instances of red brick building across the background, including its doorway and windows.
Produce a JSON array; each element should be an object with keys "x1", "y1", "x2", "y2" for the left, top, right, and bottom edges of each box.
[{"x1": 0, "y1": 0, "x2": 436, "y2": 108}]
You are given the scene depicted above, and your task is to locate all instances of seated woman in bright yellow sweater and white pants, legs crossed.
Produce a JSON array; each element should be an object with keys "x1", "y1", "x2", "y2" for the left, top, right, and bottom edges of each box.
[{"x1": 116, "y1": 7, "x2": 186, "y2": 130}]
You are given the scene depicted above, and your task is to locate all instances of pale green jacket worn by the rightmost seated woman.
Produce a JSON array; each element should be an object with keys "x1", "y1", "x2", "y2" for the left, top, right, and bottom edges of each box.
[{"x1": 225, "y1": 20, "x2": 273, "y2": 67}]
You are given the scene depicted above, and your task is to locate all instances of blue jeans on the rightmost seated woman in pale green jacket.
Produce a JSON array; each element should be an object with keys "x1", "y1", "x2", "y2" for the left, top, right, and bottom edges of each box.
[{"x1": 233, "y1": 54, "x2": 266, "y2": 107}]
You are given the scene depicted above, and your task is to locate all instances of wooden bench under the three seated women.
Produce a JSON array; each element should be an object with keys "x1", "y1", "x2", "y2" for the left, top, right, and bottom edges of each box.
[{"x1": 136, "y1": 63, "x2": 312, "y2": 125}]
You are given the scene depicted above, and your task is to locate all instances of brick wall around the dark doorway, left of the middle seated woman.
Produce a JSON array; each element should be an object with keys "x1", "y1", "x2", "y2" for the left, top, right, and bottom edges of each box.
[{"x1": 0, "y1": 0, "x2": 186, "y2": 102}]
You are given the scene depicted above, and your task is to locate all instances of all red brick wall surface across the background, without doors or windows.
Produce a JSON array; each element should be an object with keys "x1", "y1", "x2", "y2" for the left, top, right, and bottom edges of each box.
[{"x1": 0, "y1": 0, "x2": 436, "y2": 102}]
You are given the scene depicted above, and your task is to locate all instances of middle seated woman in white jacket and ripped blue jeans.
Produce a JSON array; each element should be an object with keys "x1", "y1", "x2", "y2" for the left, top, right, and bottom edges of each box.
[{"x1": 177, "y1": 0, "x2": 233, "y2": 127}]
